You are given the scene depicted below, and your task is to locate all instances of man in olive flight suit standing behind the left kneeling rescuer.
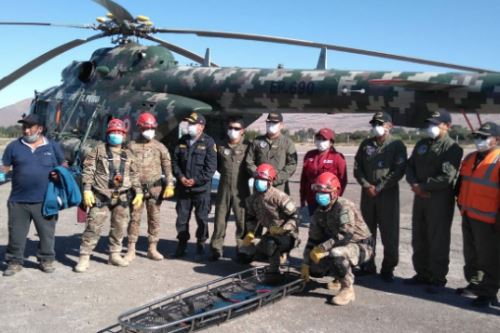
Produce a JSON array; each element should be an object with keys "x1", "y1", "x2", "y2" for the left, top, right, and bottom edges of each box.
[{"x1": 245, "y1": 112, "x2": 297, "y2": 194}]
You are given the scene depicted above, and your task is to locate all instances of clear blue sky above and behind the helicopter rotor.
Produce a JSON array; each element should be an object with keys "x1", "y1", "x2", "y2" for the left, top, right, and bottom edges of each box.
[{"x1": 0, "y1": 0, "x2": 500, "y2": 107}]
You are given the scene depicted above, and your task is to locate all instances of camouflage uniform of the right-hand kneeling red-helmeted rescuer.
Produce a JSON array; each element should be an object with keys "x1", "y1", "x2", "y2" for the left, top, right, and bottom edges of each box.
[{"x1": 304, "y1": 197, "x2": 373, "y2": 288}]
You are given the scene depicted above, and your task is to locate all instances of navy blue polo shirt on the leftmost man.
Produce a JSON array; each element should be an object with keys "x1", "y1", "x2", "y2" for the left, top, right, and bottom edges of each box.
[{"x1": 2, "y1": 138, "x2": 64, "y2": 203}]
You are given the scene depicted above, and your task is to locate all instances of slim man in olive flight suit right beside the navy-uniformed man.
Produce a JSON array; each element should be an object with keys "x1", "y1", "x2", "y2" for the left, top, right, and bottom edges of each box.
[{"x1": 210, "y1": 118, "x2": 250, "y2": 261}]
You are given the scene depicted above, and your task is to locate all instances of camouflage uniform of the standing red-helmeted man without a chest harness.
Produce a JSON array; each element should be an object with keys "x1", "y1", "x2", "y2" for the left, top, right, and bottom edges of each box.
[{"x1": 128, "y1": 138, "x2": 174, "y2": 243}]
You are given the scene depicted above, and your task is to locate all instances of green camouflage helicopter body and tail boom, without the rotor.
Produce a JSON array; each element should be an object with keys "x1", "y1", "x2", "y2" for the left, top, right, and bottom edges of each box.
[{"x1": 31, "y1": 43, "x2": 500, "y2": 160}]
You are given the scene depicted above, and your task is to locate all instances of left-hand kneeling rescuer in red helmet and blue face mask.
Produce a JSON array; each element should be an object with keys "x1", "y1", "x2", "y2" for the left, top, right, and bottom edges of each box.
[{"x1": 242, "y1": 163, "x2": 299, "y2": 283}]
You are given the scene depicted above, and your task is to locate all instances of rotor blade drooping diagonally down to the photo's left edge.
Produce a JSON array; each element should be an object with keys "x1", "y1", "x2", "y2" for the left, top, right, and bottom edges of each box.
[{"x1": 0, "y1": 33, "x2": 107, "y2": 90}]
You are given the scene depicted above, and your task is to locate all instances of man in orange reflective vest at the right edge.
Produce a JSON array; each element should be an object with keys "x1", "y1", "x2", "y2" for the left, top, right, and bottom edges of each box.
[{"x1": 457, "y1": 122, "x2": 500, "y2": 307}]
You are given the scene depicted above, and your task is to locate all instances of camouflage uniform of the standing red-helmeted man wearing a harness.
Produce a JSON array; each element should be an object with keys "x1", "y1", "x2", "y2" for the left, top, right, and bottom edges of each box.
[{"x1": 80, "y1": 143, "x2": 141, "y2": 255}]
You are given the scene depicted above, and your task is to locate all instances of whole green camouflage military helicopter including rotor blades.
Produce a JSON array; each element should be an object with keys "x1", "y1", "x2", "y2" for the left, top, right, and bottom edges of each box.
[{"x1": 0, "y1": 0, "x2": 500, "y2": 161}]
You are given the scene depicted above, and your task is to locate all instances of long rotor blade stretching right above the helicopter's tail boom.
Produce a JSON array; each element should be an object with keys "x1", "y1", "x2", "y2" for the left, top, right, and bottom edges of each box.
[{"x1": 152, "y1": 28, "x2": 497, "y2": 73}]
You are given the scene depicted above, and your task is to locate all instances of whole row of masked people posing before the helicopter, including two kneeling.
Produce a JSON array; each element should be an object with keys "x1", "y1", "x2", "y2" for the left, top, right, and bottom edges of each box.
[{"x1": 3, "y1": 110, "x2": 500, "y2": 306}]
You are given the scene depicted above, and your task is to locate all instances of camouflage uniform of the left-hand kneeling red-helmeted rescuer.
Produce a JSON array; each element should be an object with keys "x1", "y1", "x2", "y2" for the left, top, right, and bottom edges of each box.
[{"x1": 246, "y1": 187, "x2": 299, "y2": 271}]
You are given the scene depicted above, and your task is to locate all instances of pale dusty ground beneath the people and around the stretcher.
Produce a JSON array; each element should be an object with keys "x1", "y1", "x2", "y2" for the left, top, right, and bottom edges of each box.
[{"x1": 0, "y1": 146, "x2": 500, "y2": 333}]
